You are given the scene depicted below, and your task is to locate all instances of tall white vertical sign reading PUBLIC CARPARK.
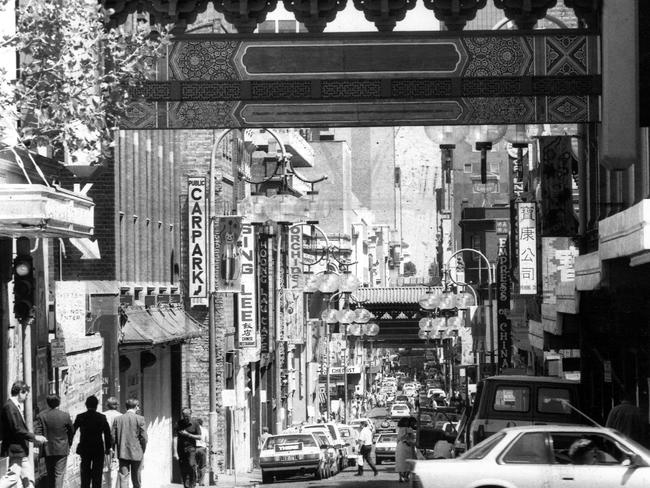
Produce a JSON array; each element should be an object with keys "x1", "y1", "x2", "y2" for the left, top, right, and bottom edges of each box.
[{"x1": 187, "y1": 176, "x2": 208, "y2": 306}]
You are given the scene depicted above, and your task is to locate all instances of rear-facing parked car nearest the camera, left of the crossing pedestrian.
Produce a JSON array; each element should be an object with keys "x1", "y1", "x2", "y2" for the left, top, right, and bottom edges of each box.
[{"x1": 260, "y1": 432, "x2": 329, "y2": 483}]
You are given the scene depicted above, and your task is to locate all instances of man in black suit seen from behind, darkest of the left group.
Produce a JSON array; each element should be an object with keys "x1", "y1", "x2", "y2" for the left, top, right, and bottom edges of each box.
[{"x1": 74, "y1": 395, "x2": 111, "y2": 488}]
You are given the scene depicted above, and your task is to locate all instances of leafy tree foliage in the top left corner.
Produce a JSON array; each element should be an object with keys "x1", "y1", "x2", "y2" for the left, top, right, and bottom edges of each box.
[{"x1": 0, "y1": 0, "x2": 168, "y2": 164}]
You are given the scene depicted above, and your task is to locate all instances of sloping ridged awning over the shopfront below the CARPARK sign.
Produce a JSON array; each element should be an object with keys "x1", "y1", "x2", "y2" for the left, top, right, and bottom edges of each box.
[{"x1": 120, "y1": 308, "x2": 203, "y2": 346}]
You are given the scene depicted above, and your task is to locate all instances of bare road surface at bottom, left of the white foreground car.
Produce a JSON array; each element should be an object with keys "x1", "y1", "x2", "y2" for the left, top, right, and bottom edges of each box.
[{"x1": 260, "y1": 463, "x2": 407, "y2": 488}]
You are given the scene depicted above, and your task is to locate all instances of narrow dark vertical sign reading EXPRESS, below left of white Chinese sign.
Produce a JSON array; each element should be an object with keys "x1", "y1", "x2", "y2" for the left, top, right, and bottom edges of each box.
[{"x1": 497, "y1": 238, "x2": 512, "y2": 371}]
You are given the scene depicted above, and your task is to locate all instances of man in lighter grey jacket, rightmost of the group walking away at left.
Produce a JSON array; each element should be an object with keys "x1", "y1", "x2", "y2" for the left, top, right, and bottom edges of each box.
[{"x1": 112, "y1": 398, "x2": 147, "y2": 488}]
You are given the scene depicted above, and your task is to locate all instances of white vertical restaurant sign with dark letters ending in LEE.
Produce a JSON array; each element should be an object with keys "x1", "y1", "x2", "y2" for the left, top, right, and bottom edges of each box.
[{"x1": 237, "y1": 221, "x2": 257, "y2": 349}]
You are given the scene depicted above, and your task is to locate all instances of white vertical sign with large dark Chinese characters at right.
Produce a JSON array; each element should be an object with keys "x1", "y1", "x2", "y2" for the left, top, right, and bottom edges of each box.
[{"x1": 517, "y1": 203, "x2": 537, "y2": 295}]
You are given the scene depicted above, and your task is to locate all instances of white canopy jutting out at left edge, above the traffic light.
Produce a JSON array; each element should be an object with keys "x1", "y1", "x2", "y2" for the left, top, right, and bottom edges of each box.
[{"x1": 0, "y1": 184, "x2": 95, "y2": 237}]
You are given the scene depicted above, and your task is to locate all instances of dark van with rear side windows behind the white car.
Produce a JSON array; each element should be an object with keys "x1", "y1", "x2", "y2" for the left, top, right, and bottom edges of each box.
[{"x1": 455, "y1": 375, "x2": 589, "y2": 453}]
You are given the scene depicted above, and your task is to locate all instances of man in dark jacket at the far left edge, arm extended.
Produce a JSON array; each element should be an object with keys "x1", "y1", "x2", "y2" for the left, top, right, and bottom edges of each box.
[{"x1": 0, "y1": 380, "x2": 47, "y2": 488}]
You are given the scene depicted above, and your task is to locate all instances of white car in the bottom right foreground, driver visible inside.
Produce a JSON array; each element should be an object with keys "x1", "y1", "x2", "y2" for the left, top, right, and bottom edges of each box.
[{"x1": 411, "y1": 425, "x2": 650, "y2": 488}]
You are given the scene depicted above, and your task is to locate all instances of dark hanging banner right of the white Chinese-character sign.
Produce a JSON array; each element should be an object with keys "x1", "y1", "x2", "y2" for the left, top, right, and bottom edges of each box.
[{"x1": 539, "y1": 136, "x2": 578, "y2": 237}]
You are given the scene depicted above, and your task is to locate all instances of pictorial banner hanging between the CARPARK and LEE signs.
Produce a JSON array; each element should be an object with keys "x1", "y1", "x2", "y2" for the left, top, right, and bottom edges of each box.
[{"x1": 217, "y1": 215, "x2": 242, "y2": 293}]
